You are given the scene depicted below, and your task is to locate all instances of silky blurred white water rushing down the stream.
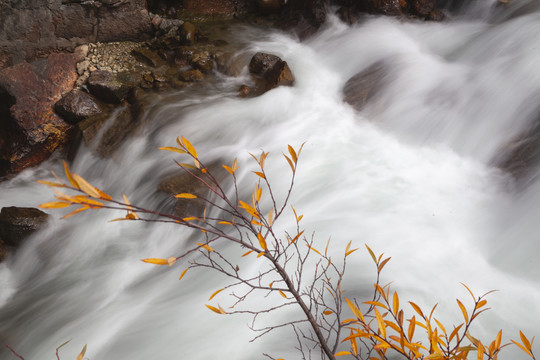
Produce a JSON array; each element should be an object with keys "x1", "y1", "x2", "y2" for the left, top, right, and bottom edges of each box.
[{"x1": 0, "y1": 0, "x2": 540, "y2": 360}]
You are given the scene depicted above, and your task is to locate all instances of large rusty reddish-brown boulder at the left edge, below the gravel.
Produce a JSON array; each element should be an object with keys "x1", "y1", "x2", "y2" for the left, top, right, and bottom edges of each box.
[{"x1": 0, "y1": 54, "x2": 77, "y2": 178}]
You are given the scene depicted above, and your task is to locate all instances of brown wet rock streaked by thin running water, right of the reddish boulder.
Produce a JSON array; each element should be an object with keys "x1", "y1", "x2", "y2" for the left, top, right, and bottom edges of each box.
[{"x1": 77, "y1": 104, "x2": 138, "y2": 158}]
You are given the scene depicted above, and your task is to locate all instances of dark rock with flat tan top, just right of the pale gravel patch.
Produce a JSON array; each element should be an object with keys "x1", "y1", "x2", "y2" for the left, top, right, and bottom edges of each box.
[{"x1": 87, "y1": 70, "x2": 141, "y2": 103}]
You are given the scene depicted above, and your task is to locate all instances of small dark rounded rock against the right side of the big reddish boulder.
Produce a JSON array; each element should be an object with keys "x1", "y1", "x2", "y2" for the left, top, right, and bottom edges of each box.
[{"x1": 54, "y1": 90, "x2": 103, "y2": 124}]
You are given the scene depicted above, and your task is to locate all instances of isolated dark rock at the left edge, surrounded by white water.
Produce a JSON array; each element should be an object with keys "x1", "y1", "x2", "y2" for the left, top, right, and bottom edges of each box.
[{"x1": 0, "y1": 206, "x2": 49, "y2": 248}]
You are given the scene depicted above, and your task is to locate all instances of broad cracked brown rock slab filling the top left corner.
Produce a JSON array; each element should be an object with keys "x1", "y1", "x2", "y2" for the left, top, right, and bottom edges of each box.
[{"x1": 0, "y1": 0, "x2": 153, "y2": 69}]
